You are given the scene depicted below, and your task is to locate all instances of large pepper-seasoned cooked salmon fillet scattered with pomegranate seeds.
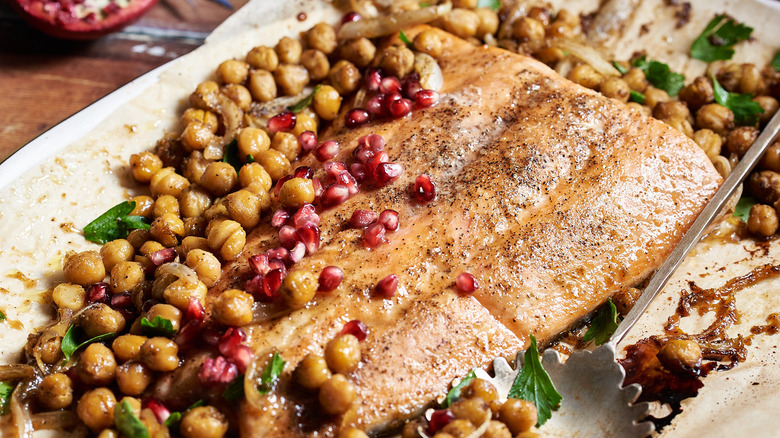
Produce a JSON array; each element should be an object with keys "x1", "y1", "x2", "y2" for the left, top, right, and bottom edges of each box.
[{"x1": 210, "y1": 27, "x2": 721, "y2": 437}]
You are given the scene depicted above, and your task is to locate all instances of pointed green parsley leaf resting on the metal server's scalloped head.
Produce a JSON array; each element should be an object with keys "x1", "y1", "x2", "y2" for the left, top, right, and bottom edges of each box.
[{"x1": 509, "y1": 335, "x2": 563, "y2": 427}]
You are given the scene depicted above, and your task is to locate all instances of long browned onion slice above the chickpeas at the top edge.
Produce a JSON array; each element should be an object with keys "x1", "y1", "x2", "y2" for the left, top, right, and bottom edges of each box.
[{"x1": 338, "y1": 1, "x2": 452, "y2": 40}]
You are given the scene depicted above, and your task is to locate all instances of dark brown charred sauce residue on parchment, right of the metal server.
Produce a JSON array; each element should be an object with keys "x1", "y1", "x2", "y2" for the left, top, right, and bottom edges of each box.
[{"x1": 619, "y1": 265, "x2": 780, "y2": 429}]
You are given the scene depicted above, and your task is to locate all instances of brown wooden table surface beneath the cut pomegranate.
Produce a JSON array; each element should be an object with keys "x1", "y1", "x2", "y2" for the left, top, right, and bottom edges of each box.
[{"x1": 0, "y1": 0, "x2": 247, "y2": 162}]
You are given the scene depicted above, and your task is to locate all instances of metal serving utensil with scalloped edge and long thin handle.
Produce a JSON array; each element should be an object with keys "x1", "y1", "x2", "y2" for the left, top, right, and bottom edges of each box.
[{"x1": 477, "y1": 112, "x2": 780, "y2": 438}]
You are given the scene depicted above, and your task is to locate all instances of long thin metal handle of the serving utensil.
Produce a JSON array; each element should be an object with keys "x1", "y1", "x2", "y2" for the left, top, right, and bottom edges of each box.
[{"x1": 610, "y1": 111, "x2": 780, "y2": 344}]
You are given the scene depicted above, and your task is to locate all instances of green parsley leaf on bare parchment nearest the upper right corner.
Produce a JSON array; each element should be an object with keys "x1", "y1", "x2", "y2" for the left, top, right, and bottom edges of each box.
[{"x1": 691, "y1": 14, "x2": 753, "y2": 62}]
